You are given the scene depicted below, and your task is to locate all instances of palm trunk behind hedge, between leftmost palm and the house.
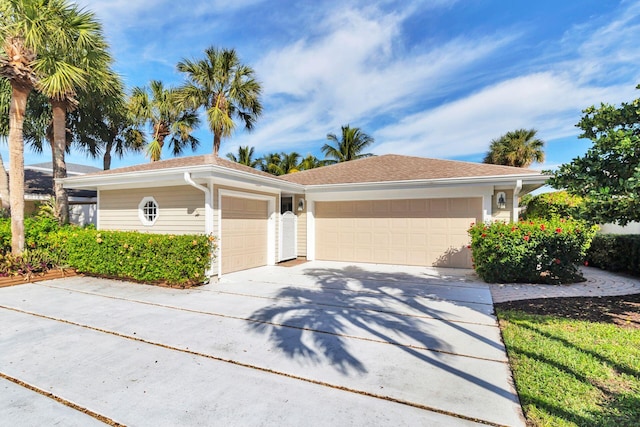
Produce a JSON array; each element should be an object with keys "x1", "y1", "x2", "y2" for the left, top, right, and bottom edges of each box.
[{"x1": 51, "y1": 99, "x2": 69, "y2": 224}]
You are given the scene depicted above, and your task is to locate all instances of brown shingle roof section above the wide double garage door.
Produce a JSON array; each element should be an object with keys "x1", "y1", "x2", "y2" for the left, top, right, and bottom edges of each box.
[{"x1": 282, "y1": 154, "x2": 540, "y2": 185}]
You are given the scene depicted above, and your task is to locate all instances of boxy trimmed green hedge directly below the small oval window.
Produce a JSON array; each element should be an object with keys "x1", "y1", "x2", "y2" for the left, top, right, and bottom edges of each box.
[{"x1": 49, "y1": 227, "x2": 215, "y2": 285}]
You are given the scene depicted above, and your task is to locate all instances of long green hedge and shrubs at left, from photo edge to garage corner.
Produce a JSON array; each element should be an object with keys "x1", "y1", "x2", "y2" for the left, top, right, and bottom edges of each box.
[{"x1": 0, "y1": 216, "x2": 215, "y2": 285}]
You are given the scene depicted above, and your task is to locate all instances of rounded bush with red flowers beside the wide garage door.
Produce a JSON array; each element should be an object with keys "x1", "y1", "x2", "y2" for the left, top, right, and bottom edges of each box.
[{"x1": 469, "y1": 218, "x2": 597, "y2": 284}]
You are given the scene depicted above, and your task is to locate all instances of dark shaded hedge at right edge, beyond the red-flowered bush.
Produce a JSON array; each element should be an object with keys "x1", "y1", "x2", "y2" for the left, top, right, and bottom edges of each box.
[{"x1": 587, "y1": 234, "x2": 640, "y2": 276}]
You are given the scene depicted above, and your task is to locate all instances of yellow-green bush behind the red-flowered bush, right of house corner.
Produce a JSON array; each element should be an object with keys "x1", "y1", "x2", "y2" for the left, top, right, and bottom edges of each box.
[{"x1": 522, "y1": 191, "x2": 584, "y2": 220}]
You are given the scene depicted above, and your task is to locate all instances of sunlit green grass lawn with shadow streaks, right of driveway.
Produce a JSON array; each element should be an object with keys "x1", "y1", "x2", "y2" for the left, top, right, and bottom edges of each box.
[{"x1": 497, "y1": 309, "x2": 640, "y2": 427}]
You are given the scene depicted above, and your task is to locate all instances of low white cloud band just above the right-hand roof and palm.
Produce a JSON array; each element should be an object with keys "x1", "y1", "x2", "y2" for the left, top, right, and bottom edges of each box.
[{"x1": 374, "y1": 72, "x2": 633, "y2": 157}]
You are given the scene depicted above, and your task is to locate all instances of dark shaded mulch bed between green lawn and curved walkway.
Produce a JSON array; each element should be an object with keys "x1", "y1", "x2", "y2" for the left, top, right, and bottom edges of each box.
[{"x1": 495, "y1": 294, "x2": 640, "y2": 329}]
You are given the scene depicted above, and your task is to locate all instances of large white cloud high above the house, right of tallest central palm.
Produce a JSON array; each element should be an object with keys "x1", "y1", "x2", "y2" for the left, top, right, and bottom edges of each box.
[{"x1": 245, "y1": 5, "x2": 516, "y2": 155}]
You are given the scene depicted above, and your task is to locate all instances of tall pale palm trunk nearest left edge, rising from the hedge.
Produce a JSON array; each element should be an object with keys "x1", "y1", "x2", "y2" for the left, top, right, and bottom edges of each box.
[{"x1": 9, "y1": 84, "x2": 31, "y2": 255}]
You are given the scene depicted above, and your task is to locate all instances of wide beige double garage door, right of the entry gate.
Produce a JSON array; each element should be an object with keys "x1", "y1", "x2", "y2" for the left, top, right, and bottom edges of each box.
[{"x1": 315, "y1": 197, "x2": 482, "y2": 268}]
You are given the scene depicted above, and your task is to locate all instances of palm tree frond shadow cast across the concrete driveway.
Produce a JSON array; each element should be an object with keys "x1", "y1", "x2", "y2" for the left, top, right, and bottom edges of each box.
[{"x1": 245, "y1": 266, "x2": 513, "y2": 399}]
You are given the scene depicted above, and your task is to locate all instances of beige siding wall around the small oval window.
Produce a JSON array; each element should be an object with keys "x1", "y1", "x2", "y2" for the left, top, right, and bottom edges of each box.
[{"x1": 98, "y1": 186, "x2": 205, "y2": 234}]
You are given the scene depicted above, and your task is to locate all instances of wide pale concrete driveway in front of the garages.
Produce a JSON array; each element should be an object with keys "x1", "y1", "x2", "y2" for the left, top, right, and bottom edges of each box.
[{"x1": 0, "y1": 262, "x2": 524, "y2": 426}]
